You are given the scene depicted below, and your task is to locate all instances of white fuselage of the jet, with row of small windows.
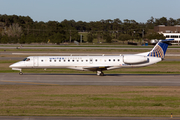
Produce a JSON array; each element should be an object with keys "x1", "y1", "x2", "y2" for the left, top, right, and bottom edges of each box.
[{"x1": 10, "y1": 55, "x2": 161, "y2": 71}]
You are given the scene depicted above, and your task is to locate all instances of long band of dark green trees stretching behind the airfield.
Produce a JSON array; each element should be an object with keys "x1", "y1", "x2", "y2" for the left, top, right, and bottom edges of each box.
[{"x1": 0, "y1": 15, "x2": 180, "y2": 44}]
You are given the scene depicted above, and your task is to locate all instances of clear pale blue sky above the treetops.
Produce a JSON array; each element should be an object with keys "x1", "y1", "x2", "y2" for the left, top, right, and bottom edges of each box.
[{"x1": 0, "y1": 0, "x2": 180, "y2": 23}]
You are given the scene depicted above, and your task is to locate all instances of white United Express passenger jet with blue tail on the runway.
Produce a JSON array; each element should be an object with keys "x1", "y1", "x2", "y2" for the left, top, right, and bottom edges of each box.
[{"x1": 9, "y1": 39, "x2": 174, "y2": 76}]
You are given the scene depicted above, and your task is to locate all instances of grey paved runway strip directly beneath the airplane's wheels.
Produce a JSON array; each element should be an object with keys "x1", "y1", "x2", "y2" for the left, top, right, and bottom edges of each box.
[{"x1": 0, "y1": 73, "x2": 180, "y2": 86}]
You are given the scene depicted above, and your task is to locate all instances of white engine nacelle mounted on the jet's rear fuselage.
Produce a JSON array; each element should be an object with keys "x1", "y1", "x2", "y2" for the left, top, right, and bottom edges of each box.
[{"x1": 123, "y1": 55, "x2": 148, "y2": 64}]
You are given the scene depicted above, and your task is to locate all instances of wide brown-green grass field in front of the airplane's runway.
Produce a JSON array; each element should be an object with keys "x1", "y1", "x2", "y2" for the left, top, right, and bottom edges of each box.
[{"x1": 0, "y1": 85, "x2": 180, "y2": 117}]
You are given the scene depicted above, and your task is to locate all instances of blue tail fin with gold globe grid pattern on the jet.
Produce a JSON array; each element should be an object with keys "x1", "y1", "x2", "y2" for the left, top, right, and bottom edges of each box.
[{"x1": 147, "y1": 39, "x2": 174, "y2": 58}]
